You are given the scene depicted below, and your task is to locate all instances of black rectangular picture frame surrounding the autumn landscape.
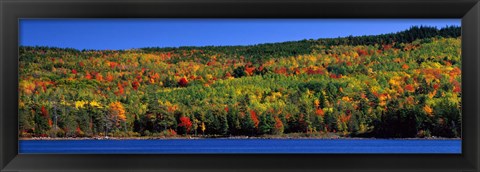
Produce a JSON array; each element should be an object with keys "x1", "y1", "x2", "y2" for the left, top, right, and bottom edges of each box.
[{"x1": 0, "y1": 0, "x2": 480, "y2": 172}]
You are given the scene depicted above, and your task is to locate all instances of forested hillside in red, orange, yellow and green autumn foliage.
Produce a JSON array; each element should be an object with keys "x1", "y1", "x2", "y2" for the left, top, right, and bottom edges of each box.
[{"x1": 19, "y1": 27, "x2": 461, "y2": 138}]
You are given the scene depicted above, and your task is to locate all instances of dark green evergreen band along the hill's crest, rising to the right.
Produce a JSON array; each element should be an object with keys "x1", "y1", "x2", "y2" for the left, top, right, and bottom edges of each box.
[{"x1": 137, "y1": 26, "x2": 461, "y2": 62}]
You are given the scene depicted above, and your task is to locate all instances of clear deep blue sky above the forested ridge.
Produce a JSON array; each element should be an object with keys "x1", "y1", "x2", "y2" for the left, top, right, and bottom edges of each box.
[{"x1": 19, "y1": 19, "x2": 461, "y2": 50}]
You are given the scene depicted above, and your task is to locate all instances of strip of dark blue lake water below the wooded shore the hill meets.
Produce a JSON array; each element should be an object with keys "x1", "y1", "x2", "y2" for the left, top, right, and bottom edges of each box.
[{"x1": 19, "y1": 139, "x2": 461, "y2": 154}]
